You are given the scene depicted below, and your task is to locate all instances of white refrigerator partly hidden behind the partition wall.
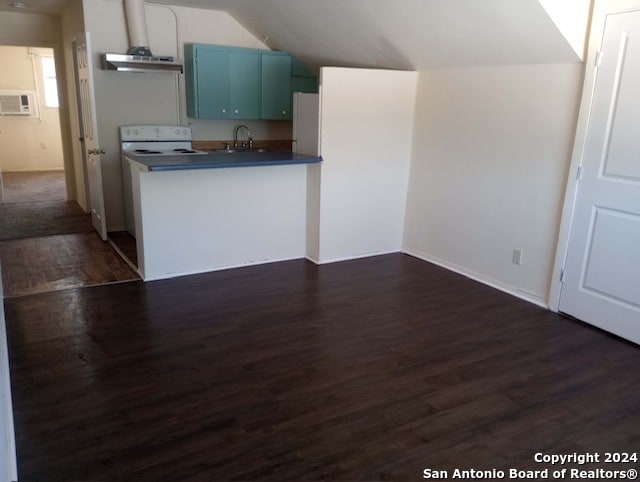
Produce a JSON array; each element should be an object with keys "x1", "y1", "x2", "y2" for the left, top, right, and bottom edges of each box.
[{"x1": 291, "y1": 92, "x2": 320, "y2": 156}]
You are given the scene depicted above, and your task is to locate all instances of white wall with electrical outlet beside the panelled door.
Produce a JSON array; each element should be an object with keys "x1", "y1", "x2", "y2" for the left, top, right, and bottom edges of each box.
[{"x1": 404, "y1": 64, "x2": 583, "y2": 304}]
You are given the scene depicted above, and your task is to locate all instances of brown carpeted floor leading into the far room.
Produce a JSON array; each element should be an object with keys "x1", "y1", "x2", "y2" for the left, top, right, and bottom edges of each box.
[{"x1": 0, "y1": 171, "x2": 93, "y2": 240}]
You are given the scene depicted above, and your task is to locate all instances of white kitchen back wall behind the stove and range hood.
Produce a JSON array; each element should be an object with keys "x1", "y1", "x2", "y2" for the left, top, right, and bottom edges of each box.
[{"x1": 83, "y1": 0, "x2": 291, "y2": 231}]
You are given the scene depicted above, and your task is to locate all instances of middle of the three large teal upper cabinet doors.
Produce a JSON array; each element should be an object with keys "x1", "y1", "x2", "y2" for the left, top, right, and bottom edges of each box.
[{"x1": 228, "y1": 49, "x2": 260, "y2": 119}]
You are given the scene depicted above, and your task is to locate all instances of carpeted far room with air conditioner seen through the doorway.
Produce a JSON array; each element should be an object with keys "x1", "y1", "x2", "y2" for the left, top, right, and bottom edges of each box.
[{"x1": 0, "y1": 46, "x2": 90, "y2": 240}]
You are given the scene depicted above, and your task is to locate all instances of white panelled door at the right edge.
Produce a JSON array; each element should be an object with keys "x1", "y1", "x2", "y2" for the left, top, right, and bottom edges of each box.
[{"x1": 560, "y1": 11, "x2": 640, "y2": 344}]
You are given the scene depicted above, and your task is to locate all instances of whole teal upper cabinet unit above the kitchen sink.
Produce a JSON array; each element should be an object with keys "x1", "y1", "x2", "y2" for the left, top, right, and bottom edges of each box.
[{"x1": 185, "y1": 44, "x2": 318, "y2": 120}]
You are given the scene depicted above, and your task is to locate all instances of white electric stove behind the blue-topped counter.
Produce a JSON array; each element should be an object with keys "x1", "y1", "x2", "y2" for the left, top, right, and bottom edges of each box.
[{"x1": 120, "y1": 125, "x2": 207, "y2": 237}]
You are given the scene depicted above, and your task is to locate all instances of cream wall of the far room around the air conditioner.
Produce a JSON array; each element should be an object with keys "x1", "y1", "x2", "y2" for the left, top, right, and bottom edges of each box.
[{"x1": 0, "y1": 46, "x2": 64, "y2": 172}]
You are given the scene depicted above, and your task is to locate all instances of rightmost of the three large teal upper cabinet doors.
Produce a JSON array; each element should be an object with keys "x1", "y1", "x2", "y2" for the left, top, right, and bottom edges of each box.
[{"x1": 261, "y1": 52, "x2": 292, "y2": 120}]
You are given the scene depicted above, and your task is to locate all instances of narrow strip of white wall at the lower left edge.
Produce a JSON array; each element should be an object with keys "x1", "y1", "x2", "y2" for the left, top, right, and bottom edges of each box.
[{"x1": 0, "y1": 264, "x2": 18, "y2": 482}]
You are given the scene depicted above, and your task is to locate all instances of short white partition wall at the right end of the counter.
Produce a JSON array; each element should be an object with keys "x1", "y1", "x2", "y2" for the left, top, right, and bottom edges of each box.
[{"x1": 308, "y1": 67, "x2": 417, "y2": 263}]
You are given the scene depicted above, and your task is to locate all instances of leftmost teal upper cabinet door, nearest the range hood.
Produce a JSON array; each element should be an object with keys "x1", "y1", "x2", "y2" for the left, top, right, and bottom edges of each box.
[{"x1": 195, "y1": 47, "x2": 231, "y2": 119}]
